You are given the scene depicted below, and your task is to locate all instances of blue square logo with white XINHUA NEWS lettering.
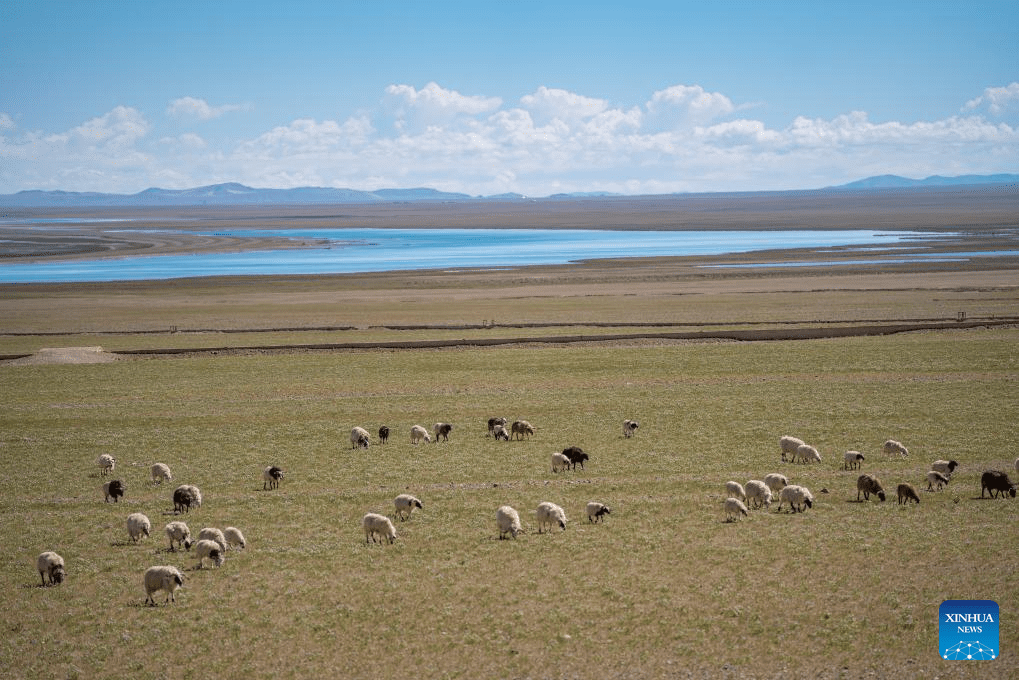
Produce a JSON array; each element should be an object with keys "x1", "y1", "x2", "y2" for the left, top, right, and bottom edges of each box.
[{"x1": 937, "y1": 599, "x2": 1001, "y2": 661}]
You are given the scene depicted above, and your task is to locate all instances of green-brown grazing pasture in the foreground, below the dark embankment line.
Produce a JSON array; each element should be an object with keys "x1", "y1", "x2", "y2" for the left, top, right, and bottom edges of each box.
[{"x1": 0, "y1": 329, "x2": 1019, "y2": 678}]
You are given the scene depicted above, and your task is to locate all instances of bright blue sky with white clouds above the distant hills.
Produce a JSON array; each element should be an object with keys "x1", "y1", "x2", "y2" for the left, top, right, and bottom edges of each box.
[{"x1": 0, "y1": 0, "x2": 1019, "y2": 196}]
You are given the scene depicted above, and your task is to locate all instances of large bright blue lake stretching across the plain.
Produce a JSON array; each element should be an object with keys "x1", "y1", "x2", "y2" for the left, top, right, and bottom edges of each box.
[{"x1": 0, "y1": 226, "x2": 933, "y2": 283}]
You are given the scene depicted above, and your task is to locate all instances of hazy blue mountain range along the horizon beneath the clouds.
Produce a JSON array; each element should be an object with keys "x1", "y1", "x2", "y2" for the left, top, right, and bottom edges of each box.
[{"x1": 0, "y1": 174, "x2": 1019, "y2": 208}]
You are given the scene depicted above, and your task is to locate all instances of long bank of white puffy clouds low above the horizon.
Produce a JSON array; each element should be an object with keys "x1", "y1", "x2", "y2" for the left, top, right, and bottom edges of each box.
[{"x1": 0, "y1": 83, "x2": 1019, "y2": 196}]
